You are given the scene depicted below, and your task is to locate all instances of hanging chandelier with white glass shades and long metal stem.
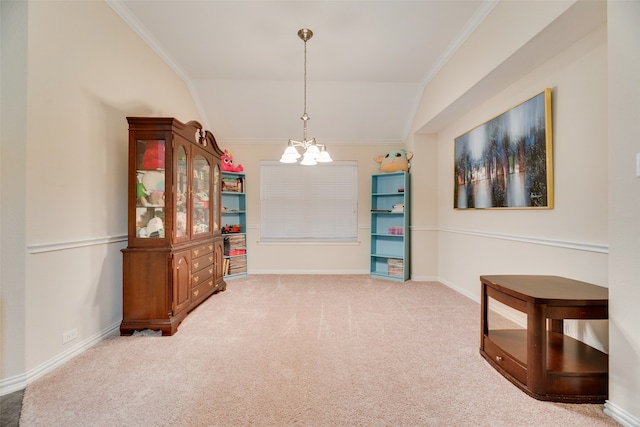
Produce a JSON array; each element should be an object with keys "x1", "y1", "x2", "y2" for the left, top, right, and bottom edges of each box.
[{"x1": 280, "y1": 28, "x2": 333, "y2": 165}]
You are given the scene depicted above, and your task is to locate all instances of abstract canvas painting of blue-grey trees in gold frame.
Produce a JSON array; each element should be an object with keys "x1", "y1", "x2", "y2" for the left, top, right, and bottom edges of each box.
[{"x1": 453, "y1": 89, "x2": 553, "y2": 209}]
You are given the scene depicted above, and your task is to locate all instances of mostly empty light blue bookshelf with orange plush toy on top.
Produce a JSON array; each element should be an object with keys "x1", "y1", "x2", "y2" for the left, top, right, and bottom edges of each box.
[{"x1": 370, "y1": 172, "x2": 411, "y2": 281}]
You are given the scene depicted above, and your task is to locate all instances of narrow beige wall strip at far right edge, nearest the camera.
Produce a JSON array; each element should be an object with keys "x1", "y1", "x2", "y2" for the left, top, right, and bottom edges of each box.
[{"x1": 607, "y1": 1, "x2": 640, "y2": 425}]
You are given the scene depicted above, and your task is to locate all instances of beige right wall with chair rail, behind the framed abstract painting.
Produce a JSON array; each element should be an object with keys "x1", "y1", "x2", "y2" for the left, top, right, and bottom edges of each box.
[{"x1": 413, "y1": 3, "x2": 609, "y2": 358}]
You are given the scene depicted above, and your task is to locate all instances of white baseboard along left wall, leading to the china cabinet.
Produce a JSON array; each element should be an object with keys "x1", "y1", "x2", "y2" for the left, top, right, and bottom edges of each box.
[{"x1": 0, "y1": 321, "x2": 120, "y2": 396}]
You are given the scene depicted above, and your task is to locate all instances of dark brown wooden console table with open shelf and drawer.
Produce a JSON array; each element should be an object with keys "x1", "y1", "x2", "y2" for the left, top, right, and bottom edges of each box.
[{"x1": 480, "y1": 275, "x2": 609, "y2": 403}]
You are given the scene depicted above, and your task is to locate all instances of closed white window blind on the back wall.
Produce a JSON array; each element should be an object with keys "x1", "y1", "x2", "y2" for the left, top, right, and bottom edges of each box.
[{"x1": 260, "y1": 161, "x2": 358, "y2": 240}]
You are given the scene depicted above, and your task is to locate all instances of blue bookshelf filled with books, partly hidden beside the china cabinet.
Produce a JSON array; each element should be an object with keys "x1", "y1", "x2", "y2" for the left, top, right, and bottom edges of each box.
[{"x1": 222, "y1": 172, "x2": 247, "y2": 279}]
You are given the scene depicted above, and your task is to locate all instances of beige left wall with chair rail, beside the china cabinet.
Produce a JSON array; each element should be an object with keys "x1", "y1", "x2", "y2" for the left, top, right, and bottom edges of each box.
[{"x1": 1, "y1": 2, "x2": 199, "y2": 388}]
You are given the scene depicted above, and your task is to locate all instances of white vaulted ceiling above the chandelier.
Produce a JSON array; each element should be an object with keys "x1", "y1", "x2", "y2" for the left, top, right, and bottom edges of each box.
[{"x1": 108, "y1": 0, "x2": 495, "y2": 143}]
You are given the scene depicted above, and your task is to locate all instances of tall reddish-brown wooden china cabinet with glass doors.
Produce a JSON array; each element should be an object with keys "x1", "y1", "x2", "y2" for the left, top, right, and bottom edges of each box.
[{"x1": 120, "y1": 117, "x2": 226, "y2": 335}]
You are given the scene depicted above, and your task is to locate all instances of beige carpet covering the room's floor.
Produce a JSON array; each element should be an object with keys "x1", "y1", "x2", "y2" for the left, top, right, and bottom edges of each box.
[{"x1": 21, "y1": 275, "x2": 617, "y2": 427}]
